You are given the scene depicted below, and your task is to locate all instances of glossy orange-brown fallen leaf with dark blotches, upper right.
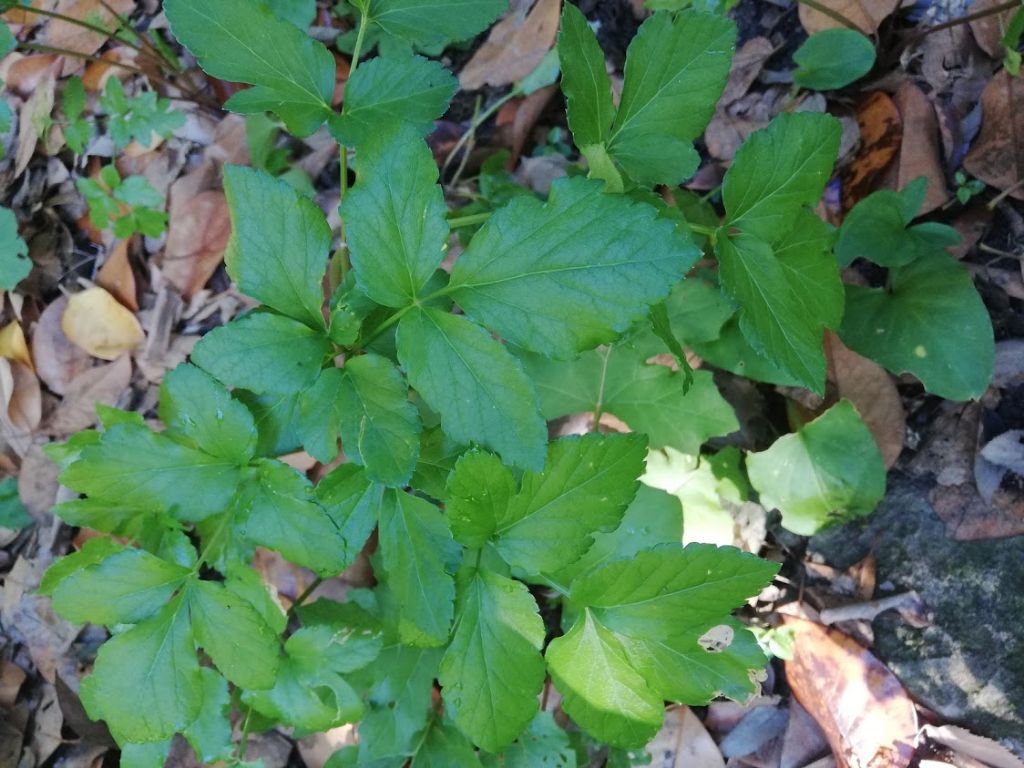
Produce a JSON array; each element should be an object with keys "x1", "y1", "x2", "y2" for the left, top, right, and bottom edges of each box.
[{"x1": 843, "y1": 93, "x2": 903, "y2": 211}]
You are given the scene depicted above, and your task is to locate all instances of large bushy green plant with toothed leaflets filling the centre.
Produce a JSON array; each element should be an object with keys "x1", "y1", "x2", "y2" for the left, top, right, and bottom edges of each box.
[{"x1": 41, "y1": 0, "x2": 991, "y2": 766}]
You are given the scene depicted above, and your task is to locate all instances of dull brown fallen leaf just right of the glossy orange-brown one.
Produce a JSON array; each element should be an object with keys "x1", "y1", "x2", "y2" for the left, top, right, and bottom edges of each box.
[{"x1": 885, "y1": 82, "x2": 949, "y2": 216}]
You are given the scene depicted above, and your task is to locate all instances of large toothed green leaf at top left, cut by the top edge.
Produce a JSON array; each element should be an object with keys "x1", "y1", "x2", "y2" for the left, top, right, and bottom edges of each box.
[{"x1": 164, "y1": 0, "x2": 335, "y2": 136}]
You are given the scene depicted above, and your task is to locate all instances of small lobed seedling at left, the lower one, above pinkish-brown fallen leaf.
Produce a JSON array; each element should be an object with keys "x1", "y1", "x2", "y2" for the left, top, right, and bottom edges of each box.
[{"x1": 77, "y1": 165, "x2": 167, "y2": 238}]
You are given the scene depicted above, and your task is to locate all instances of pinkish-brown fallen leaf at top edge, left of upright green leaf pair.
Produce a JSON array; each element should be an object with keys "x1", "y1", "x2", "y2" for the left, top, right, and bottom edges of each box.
[{"x1": 459, "y1": 0, "x2": 561, "y2": 91}]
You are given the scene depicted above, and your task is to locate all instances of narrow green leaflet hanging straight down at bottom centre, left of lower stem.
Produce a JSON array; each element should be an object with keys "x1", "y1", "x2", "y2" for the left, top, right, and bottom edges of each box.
[{"x1": 378, "y1": 490, "x2": 460, "y2": 646}]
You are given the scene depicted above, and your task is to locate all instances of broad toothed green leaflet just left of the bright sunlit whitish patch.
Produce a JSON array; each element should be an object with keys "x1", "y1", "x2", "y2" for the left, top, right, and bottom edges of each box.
[{"x1": 491, "y1": 434, "x2": 647, "y2": 574}]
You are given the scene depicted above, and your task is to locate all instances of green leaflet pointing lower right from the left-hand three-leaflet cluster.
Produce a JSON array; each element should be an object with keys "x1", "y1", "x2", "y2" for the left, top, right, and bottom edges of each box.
[{"x1": 239, "y1": 461, "x2": 349, "y2": 577}]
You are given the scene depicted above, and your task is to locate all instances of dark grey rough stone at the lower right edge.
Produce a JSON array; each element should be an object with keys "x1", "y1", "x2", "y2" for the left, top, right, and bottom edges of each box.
[{"x1": 810, "y1": 473, "x2": 1024, "y2": 755}]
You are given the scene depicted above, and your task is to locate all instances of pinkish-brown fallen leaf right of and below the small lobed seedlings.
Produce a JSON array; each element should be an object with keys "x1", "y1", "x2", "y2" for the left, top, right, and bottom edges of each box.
[{"x1": 161, "y1": 186, "x2": 231, "y2": 297}]
